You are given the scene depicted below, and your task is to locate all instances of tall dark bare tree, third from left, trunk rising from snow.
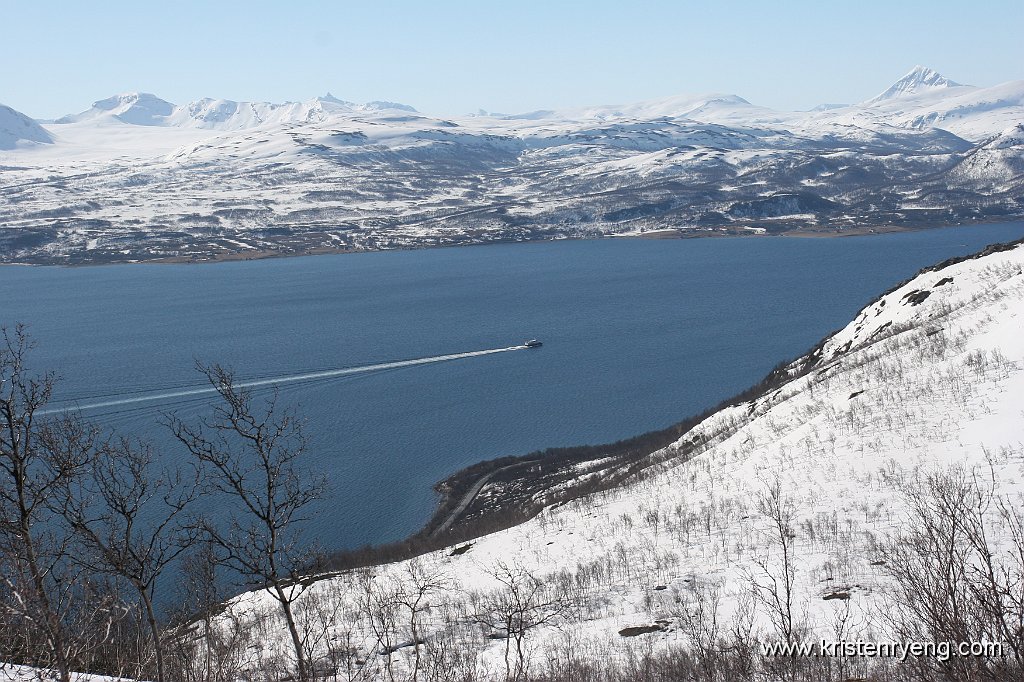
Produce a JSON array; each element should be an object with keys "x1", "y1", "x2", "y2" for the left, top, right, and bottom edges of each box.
[{"x1": 168, "y1": 365, "x2": 325, "y2": 682}]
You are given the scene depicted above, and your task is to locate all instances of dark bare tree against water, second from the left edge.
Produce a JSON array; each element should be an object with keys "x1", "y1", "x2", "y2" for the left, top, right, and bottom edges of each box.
[{"x1": 52, "y1": 437, "x2": 198, "y2": 682}]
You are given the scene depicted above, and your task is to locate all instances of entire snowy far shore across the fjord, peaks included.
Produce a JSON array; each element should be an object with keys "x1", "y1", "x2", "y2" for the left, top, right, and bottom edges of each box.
[{"x1": 0, "y1": 68, "x2": 1024, "y2": 263}]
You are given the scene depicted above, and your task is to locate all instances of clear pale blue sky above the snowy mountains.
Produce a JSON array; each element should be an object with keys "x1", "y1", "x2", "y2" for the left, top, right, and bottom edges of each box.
[{"x1": 0, "y1": 0, "x2": 1024, "y2": 119}]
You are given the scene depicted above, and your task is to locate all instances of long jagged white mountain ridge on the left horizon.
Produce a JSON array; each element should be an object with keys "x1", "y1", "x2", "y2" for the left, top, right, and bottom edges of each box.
[{"x1": 54, "y1": 92, "x2": 416, "y2": 130}]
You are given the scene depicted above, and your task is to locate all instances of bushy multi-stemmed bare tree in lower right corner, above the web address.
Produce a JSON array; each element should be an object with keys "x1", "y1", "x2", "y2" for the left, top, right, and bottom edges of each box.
[{"x1": 881, "y1": 468, "x2": 1024, "y2": 680}]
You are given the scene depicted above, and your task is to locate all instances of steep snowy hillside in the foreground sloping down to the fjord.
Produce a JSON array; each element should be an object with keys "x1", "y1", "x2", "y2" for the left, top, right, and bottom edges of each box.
[{"x1": 205, "y1": 238, "x2": 1024, "y2": 679}]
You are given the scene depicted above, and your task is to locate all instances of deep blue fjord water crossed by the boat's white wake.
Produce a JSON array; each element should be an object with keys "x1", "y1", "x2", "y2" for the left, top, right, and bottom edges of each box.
[{"x1": 0, "y1": 223, "x2": 1024, "y2": 548}]
